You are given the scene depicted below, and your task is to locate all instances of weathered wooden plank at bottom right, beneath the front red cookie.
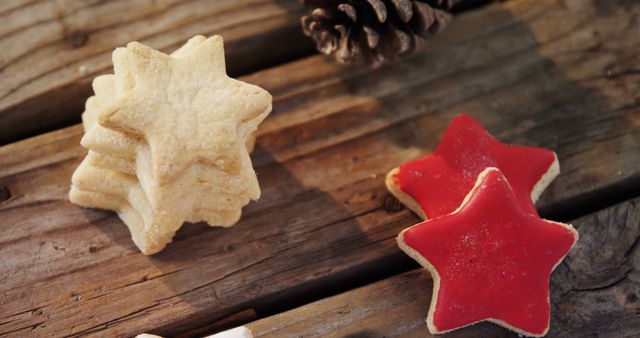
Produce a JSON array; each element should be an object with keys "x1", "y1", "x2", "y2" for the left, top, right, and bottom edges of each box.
[{"x1": 247, "y1": 199, "x2": 640, "y2": 338}]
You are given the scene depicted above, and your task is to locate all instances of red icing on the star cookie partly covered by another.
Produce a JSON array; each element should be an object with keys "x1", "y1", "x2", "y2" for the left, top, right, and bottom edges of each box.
[{"x1": 395, "y1": 114, "x2": 555, "y2": 218}]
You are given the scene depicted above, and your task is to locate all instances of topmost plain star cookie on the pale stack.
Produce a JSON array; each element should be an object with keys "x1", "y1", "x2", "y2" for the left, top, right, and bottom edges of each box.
[{"x1": 99, "y1": 36, "x2": 271, "y2": 184}]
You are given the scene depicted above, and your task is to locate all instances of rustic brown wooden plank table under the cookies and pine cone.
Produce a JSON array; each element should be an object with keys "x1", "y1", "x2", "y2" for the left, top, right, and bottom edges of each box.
[{"x1": 0, "y1": 0, "x2": 640, "y2": 337}]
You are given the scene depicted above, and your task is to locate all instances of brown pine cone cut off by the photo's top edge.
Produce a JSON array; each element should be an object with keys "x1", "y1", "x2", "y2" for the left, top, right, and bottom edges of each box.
[{"x1": 301, "y1": 0, "x2": 453, "y2": 67}]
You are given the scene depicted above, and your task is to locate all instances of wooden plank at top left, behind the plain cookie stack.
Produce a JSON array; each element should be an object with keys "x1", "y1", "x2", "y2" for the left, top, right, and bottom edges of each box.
[{"x1": 0, "y1": 0, "x2": 313, "y2": 144}]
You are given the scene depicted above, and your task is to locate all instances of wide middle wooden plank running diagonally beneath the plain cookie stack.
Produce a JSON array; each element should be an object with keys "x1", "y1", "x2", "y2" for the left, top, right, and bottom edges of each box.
[{"x1": 0, "y1": 0, "x2": 640, "y2": 336}]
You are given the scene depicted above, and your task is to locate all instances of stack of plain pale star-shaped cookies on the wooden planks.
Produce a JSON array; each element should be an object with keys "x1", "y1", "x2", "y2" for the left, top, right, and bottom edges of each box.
[{"x1": 69, "y1": 36, "x2": 271, "y2": 254}]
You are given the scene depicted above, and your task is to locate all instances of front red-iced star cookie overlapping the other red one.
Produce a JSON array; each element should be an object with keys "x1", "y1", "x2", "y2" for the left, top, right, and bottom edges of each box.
[{"x1": 400, "y1": 168, "x2": 577, "y2": 335}]
